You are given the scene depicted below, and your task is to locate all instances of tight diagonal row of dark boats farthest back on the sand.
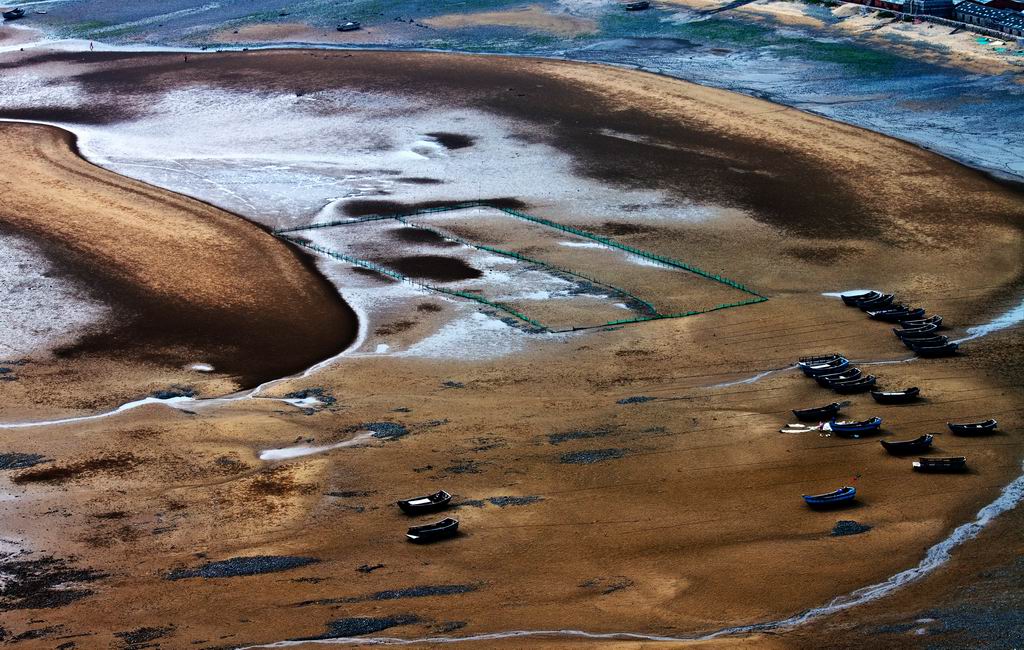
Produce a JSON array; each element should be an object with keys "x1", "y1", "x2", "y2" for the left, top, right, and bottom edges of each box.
[{"x1": 841, "y1": 291, "x2": 959, "y2": 357}]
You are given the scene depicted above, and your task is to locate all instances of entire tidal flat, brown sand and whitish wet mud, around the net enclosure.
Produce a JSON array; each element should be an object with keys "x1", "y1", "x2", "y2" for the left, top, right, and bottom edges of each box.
[{"x1": 0, "y1": 50, "x2": 1024, "y2": 647}]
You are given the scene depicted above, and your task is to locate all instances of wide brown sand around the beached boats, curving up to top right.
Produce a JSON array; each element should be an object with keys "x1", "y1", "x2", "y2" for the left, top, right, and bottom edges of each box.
[{"x1": 2, "y1": 52, "x2": 1024, "y2": 647}]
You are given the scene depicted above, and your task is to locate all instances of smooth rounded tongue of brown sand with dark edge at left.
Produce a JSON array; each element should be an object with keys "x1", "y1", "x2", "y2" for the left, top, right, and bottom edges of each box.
[{"x1": 0, "y1": 124, "x2": 355, "y2": 409}]
